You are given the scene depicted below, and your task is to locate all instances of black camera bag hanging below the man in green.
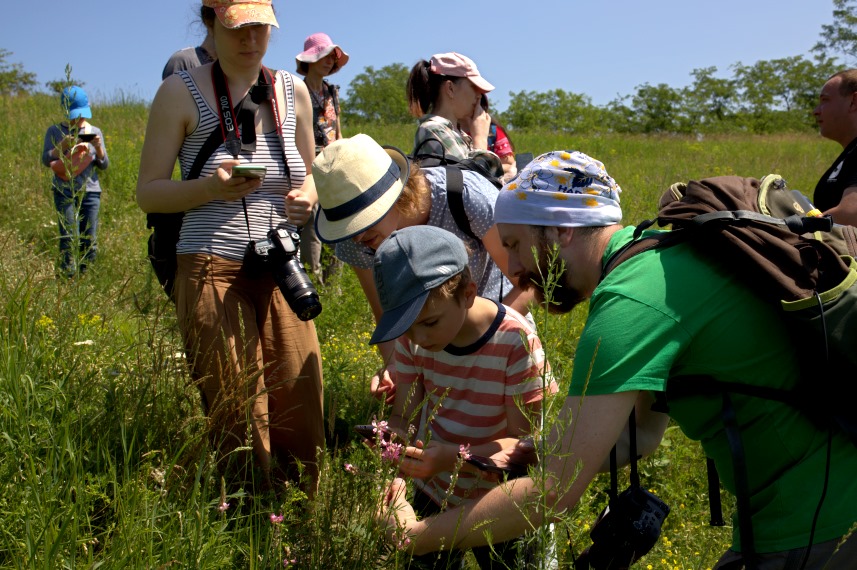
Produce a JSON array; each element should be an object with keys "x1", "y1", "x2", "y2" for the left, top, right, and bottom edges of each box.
[{"x1": 574, "y1": 486, "x2": 670, "y2": 570}]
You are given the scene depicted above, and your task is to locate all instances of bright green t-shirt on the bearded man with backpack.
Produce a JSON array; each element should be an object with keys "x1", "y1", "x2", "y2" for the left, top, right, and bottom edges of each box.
[{"x1": 569, "y1": 227, "x2": 857, "y2": 553}]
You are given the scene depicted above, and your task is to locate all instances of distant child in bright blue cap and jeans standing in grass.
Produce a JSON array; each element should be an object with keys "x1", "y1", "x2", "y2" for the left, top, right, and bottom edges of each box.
[{"x1": 42, "y1": 86, "x2": 108, "y2": 277}]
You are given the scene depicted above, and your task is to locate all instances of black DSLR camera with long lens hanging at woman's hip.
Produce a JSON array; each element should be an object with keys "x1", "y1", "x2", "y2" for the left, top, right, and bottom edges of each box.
[{"x1": 244, "y1": 227, "x2": 321, "y2": 321}]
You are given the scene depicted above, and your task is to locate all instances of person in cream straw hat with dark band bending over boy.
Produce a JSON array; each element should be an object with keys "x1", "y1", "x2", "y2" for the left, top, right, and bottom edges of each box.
[{"x1": 313, "y1": 134, "x2": 532, "y2": 400}]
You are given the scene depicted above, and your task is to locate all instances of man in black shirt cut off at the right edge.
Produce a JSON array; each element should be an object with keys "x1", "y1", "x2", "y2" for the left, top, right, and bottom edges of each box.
[{"x1": 813, "y1": 69, "x2": 857, "y2": 226}]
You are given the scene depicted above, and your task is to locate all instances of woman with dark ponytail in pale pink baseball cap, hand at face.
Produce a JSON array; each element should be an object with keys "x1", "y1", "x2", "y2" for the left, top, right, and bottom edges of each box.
[{"x1": 408, "y1": 52, "x2": 503, "y2": 178}]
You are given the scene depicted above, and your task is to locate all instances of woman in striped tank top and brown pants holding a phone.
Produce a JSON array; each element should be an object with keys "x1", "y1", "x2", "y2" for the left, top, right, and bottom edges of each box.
[{"x1": 137, "y1": 0, "x2": 324, "y2": 492}]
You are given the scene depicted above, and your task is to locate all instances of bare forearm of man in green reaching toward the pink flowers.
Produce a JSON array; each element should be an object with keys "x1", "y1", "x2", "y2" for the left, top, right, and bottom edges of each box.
[{"x1": 387, "y1": 392, "x2": 638, "y2": 554}]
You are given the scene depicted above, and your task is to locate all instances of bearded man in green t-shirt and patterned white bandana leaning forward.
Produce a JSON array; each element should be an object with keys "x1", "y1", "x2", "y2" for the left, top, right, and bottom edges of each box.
[{"x1": 388, "y1": 151, "x2": 857, "y2": 570}]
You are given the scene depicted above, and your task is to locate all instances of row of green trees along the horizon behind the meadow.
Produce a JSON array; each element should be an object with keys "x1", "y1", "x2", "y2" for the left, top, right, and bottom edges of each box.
[{"x1": 5, "y1": 0, "x2": 857, "y2": 134}]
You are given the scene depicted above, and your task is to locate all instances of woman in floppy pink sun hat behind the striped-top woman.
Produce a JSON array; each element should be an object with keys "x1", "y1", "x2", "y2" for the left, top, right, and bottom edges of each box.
[{"x1": 295, "y1": 32, "x2": 348, "y2": 283}]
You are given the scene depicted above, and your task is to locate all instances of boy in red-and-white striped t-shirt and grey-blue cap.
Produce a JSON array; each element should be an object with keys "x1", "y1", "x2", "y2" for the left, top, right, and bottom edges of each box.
[{"x1": 369, "y1": 226, "x2": 557, "y2": 568}]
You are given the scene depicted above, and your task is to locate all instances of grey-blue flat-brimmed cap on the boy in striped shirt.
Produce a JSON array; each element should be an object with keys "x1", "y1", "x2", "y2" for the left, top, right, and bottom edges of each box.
[{"x1": 369, "y1": 226, "x2": 467, "y2": 344}]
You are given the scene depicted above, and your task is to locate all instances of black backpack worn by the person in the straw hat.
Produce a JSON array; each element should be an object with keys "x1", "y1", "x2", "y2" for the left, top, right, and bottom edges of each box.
[{"x1": 408, "y1": 138, "x2": 503, "y2": 240}]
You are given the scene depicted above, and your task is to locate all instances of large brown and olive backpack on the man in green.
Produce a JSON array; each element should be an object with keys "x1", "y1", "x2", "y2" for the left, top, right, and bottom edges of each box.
[{"x1": 602, "y1": 174, "x2": 857, "y2": 568}]
